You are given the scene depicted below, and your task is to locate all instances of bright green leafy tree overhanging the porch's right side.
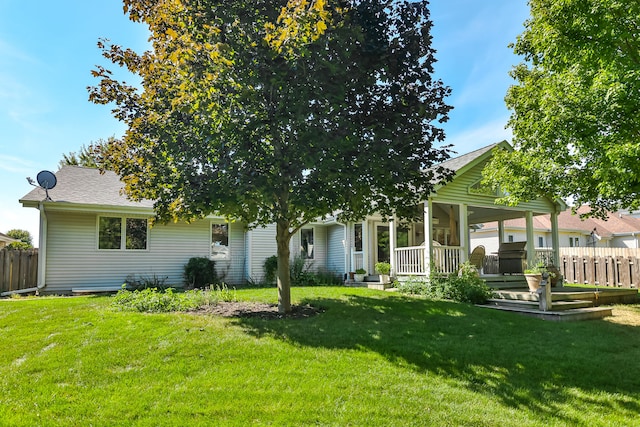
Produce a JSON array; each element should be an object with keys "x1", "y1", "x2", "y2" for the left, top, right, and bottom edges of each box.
[{"x1": 485, "y1": 0, "x2": 640, "y2": 214}]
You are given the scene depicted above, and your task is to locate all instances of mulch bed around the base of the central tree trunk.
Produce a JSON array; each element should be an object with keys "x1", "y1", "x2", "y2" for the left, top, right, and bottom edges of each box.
[{"x1": 195, "y1": 302, "x2": 324, "y2": 320}]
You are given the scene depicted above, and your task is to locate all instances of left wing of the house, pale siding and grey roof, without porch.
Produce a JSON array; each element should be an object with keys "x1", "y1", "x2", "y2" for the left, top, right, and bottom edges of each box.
[{"x1": 20, "y1": 166, "x2": 344, "y2": 293}]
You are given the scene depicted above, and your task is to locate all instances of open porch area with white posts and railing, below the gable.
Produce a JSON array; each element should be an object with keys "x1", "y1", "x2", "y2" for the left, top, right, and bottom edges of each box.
[{"x1": 348, "y1": 200, "x2": 559, "y2": 280}]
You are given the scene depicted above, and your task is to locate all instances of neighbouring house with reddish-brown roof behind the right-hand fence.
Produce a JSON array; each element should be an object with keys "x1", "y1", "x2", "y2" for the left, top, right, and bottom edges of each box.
[{"x1": 471, "y1": 206, "x2": 640, "y2": 252}]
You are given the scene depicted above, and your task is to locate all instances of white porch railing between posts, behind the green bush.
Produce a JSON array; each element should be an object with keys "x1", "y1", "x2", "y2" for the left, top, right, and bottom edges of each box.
[{"x1": 395, "y1": 246, "x2": 462, "y2": 276}]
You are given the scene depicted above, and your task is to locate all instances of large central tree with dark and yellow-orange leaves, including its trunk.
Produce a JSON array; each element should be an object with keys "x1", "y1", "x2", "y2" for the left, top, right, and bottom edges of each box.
[{"x1": 90, "y1": 0, "x2": 450, "y2": 312}]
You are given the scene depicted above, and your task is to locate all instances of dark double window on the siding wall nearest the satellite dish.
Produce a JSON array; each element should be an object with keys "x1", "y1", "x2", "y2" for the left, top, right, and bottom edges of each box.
[{"x1": 98, "y1": 216, "x2": 148, "y2": 250}]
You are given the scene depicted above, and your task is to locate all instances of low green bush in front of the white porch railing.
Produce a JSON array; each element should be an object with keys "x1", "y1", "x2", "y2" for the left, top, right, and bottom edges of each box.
[{"x1": 398, "y1": 262, "x2": 492, "y2": 304}]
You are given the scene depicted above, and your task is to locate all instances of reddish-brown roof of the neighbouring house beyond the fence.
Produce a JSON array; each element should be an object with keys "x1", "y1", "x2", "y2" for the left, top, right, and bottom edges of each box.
[{"x1": 482, "y1": 206, "x2": 640, "y2": 238}]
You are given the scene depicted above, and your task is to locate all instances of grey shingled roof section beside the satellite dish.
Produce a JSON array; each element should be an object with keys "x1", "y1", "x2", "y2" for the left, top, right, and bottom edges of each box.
[{"x1": 20, "y1": 166, "x2": 153, "y2": 208}]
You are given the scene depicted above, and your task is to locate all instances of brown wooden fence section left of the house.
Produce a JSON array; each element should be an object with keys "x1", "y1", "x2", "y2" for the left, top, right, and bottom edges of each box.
[{"x1": 0, "y1": 249, "x2": 38, "y2": 293}]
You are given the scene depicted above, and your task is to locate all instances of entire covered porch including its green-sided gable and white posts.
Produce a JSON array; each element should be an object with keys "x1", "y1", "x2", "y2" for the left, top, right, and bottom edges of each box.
[{"x1": 346, "y1": 141, "x2": 566, "y2": 286}]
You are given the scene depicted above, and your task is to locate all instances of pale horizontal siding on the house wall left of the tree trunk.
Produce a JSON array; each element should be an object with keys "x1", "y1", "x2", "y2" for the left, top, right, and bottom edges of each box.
[{"x1": 45, "y1": 211, "x2": 245, "y2": 292}]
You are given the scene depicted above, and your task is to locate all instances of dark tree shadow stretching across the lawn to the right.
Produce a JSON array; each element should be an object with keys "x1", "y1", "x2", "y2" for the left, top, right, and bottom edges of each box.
[{"x1": 235, "y1": 295, "x2": 640, "y2": 423}]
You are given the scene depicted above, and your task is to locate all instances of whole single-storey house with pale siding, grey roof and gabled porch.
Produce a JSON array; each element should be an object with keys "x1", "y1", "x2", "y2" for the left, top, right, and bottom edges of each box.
[{"x1": 20, "y1": 141, "x2": 566, "y2": 293}]
